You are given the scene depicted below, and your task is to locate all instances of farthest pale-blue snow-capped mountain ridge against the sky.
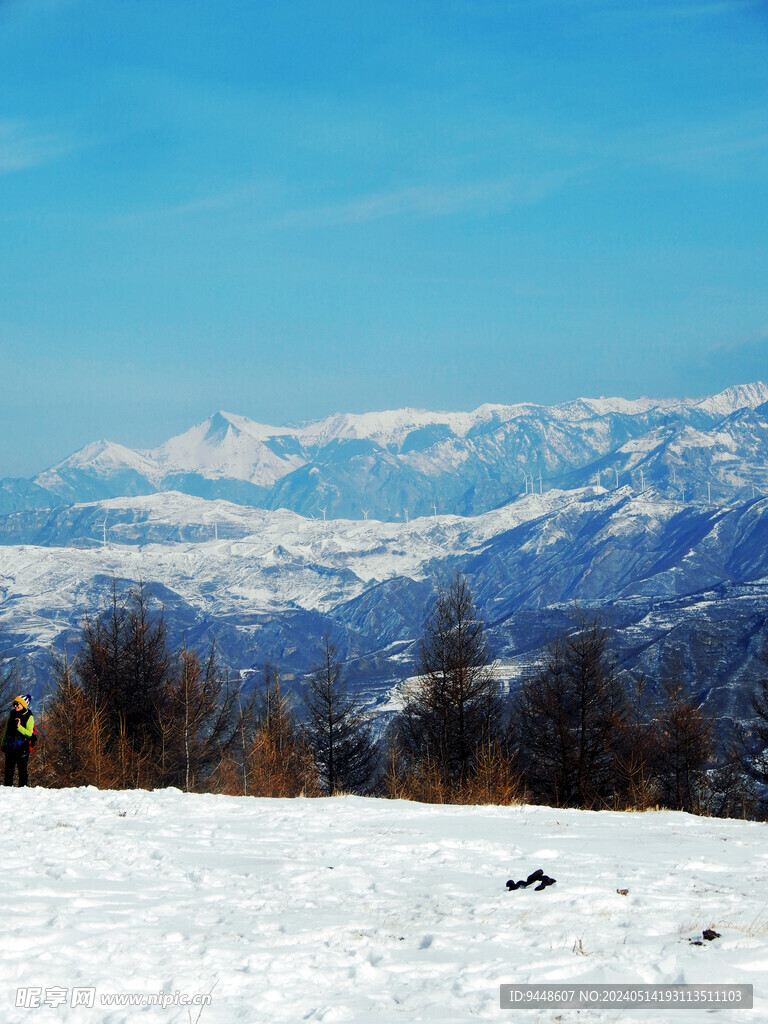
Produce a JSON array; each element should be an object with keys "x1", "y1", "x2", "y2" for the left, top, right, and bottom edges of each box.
[{"x1": 0, "y1": 382, "x2": 768, "y2": 521}]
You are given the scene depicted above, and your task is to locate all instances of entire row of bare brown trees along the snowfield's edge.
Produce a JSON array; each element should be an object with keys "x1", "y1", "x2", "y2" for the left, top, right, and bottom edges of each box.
[{"x1": 10, "y1": 575, "x2": 768, "y2": 817}]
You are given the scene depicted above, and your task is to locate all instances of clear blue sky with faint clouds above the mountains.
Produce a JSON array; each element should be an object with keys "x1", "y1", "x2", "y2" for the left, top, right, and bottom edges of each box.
[{"x1": 0, "y1": 0, "x2": 768, "y2": 476}]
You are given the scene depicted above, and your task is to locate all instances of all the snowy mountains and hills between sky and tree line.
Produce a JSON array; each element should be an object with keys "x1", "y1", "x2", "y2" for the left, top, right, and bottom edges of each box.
[{"x1": 0, "y1": 384, "x2": 768, "y2": 717}]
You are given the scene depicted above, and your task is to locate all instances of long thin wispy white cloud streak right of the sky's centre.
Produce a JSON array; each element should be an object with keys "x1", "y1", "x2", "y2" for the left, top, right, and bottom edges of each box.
[{"x1": 284, "y1": 172, "x2": 573, "y2": 227}]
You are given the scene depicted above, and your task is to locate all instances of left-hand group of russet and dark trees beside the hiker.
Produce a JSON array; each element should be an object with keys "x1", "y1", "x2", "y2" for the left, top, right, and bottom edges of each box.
[{"x1": 26, "y1": 582, "x2": 378, "y2": 797}]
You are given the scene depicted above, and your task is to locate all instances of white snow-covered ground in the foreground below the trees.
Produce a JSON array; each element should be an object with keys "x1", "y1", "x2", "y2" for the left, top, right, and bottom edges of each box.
[{"x1": 0, "y1": 788, "x2": 768, "y2": 1024}]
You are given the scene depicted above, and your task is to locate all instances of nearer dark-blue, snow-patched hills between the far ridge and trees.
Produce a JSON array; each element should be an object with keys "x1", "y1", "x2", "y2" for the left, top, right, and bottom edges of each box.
[{"x1": 0, "y1": 487, "x2": 768, "y2": 718}]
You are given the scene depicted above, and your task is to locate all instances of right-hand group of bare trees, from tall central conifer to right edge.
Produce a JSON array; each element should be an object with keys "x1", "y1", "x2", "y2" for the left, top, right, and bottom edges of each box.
[{"x1": 389, "y1": 577, "x2": 768, "y2": 817}]
